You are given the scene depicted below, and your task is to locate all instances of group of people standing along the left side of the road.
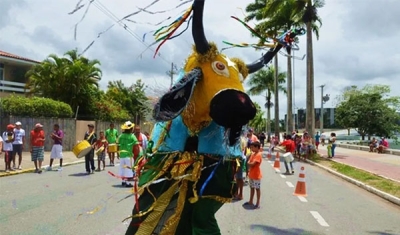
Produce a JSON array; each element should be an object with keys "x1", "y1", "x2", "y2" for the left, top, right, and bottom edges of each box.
[{"x1": 0, "y1": 121, "x2": 149, "y2": 184}]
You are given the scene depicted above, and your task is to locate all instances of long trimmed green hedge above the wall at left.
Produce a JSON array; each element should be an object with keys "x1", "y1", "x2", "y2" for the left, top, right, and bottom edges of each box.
[{"x1": 0, "y1": 95, "x2": 74, "y2": 118}]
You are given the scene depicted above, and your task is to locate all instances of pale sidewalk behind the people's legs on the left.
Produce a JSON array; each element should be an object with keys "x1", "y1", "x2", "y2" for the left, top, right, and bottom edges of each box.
[{"x1": 0, "y1": 151, "x2": 86, "y2": 177}]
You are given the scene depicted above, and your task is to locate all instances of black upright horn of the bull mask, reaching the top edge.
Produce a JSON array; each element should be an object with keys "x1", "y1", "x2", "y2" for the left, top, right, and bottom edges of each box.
[{"x1": 192, "y1": 0, "x2": 210, "y2": 54}]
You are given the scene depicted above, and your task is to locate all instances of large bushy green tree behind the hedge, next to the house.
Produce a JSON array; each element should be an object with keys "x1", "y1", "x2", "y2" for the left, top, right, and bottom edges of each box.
[{"x1": 26, "y1": 50, "x2": 102, "y2": 116}]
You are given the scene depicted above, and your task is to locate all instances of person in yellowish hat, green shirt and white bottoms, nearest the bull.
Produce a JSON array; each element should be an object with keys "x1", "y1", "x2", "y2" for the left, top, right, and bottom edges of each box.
[{"x1": 117, "y1": 121, "x2": 139, "y2": 187}]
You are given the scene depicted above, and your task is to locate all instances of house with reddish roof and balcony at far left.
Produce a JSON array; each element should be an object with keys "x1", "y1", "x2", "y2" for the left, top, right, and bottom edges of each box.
[{"x1": 0, "y1": 50, "x2": 40, "y2": 98}]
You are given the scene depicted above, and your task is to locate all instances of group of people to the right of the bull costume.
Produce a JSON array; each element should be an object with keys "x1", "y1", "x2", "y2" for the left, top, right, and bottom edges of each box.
[{"x1": 233, "y1": 128, "x2": 342, "y2": 209}]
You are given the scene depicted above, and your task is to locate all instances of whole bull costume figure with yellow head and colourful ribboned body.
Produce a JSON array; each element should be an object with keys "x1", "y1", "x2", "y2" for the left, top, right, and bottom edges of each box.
[{"x1": 126, "y1": 0, "x2": 304, "y2": 235}]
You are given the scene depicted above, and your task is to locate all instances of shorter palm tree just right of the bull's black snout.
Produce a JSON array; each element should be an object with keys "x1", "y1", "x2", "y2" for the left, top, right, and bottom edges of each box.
[{"x1": 248, "y1": 67, "x2": 286, "y2": 141}]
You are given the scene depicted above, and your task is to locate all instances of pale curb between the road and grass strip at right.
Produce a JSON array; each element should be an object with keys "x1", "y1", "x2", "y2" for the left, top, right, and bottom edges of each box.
[{"x1": 306, "y1": 159, "x2": 400, "y2": 206}]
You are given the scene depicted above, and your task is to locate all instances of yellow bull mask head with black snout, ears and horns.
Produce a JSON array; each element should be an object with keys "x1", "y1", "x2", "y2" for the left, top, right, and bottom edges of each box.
[{"x1": 153, "y1": 0, "x2": 288, "y2": 144}]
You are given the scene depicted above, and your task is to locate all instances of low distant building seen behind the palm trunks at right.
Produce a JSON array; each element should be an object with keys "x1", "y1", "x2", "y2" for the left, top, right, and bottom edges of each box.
[{"x1": 285, "y1": 108, "x2": 340, "y2": 129}]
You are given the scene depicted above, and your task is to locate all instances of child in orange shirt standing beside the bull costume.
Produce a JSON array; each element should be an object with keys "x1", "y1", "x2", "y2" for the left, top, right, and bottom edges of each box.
[{"x1": 244, "y1": 141, "x2": 262, "y2": 209}]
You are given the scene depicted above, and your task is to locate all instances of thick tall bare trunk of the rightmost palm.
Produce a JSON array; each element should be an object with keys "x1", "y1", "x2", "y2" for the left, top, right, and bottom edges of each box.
[{"x1": 306, "y1": 22, "x2": 315, "y2": 137}]
